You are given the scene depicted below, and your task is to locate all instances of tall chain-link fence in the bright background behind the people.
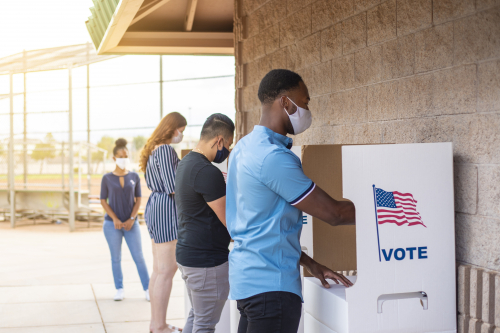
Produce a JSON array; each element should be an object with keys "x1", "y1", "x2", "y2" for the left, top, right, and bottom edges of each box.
[{"x1": 0, "y1": 50, "x2": 235, "y2": 231}]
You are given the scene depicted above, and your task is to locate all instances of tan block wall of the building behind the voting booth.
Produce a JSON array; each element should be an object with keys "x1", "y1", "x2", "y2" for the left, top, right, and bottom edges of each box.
[{"x1": 235, "y1": 0, "x2": 500, "y2": 332}]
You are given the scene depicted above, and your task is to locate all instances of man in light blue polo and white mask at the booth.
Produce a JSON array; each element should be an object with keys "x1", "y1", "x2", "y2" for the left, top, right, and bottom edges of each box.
[{"x1": 226, "y1": 69, "x2": 354, "y2": 333}]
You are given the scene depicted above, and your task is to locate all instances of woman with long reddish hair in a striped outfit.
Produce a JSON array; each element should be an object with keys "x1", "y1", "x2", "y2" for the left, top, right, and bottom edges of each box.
[{"x1": 140, "y1": 112, "x2": 187, "y2": 333}]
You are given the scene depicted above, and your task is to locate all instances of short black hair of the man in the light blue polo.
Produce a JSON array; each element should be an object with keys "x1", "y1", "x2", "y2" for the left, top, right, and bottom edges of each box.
[{"x1": 257, "y1": 69, "x2": 302, "y2": 104}]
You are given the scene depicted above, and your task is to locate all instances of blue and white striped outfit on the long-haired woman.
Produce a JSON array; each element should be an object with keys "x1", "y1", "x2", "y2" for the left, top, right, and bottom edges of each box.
[{"x1": 144, "y1": 145, "x2": 179, "y2": 243}]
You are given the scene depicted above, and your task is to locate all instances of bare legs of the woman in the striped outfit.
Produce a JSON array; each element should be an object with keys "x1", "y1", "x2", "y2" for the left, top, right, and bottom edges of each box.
[{"x1": 149, "y1": 240, "x2": 177, "y2": 333}]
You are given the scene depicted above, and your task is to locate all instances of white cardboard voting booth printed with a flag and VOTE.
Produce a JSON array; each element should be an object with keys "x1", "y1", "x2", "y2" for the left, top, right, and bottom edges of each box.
[{"x1": 294, "y1": 143, "x2": 456, "y2": 333}]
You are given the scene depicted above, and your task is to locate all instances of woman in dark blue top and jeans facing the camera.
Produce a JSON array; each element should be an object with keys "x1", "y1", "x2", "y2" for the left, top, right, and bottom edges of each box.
[{"x1": 101, "y1": 139, "x2": 149, "y2": 301}]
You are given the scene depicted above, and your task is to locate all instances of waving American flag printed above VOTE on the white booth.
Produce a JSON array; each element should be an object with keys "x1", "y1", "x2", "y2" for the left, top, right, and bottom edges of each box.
[{"x1": 375, "y1": 188, "x2": 427, "y2": 228}]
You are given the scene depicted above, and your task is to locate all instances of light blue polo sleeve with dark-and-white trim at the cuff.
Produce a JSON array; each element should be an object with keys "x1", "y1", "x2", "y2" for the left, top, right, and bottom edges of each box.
[{"x1": 260, "y1": 150, "x2": 315, "y2": 205}]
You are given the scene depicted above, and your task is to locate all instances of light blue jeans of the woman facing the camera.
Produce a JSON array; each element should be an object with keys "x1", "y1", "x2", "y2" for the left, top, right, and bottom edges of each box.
[{"x1": 102, "y1": 220, "x2": 149, "y2": 290}]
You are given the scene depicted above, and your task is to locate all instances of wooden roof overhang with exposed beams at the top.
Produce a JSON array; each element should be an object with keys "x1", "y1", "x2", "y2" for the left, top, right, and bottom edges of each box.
[{"x1": 86, "y1": 0, "x2": 234, "y2": 55}]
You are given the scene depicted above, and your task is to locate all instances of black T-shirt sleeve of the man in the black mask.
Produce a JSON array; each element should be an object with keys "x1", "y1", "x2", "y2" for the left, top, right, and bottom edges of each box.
[{"x1": 194, "y1": 165, "x2": 226, "y2": 202}]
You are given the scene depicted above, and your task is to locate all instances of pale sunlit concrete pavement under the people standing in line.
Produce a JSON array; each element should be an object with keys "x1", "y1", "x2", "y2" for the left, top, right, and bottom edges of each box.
[{"x1": 0, "y1": 222, "x2": 184, "y2": 333}]
